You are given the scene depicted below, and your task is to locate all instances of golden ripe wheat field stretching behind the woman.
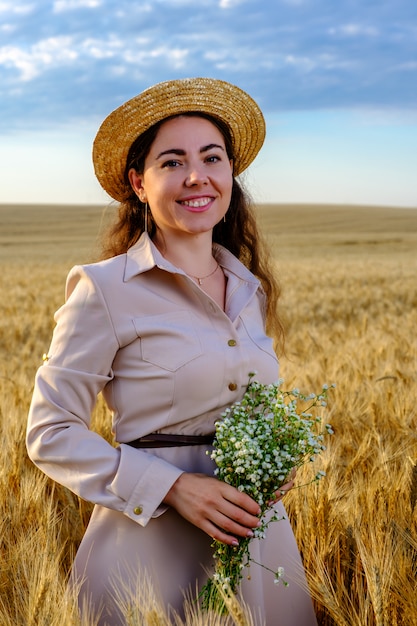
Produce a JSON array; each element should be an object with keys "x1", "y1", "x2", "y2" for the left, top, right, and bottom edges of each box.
[{"x1": 0, "y1": 205, "x2": 417, "y2": 626}]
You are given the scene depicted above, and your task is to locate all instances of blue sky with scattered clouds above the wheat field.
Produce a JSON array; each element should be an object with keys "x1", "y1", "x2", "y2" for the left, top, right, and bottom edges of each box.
[{"x1": 0, "y1": 0, "x2": 417, "y2": 207}]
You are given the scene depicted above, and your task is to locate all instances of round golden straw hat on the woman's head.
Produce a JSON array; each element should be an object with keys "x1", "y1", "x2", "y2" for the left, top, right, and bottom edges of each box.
[{"x1": 93, "y1": 78, "x2": 265, "y2": 201}]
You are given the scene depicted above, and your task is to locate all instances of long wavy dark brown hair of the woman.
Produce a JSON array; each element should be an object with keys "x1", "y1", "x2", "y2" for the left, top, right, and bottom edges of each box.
[{"x1": 100, "y1": 112, "x2": 284, "y2": 351}]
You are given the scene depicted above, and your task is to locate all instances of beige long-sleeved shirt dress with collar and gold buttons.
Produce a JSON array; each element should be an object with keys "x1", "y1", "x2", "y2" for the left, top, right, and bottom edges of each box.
[{"x1": 27, "y1": 234, "x2": 316, "y2": 626}]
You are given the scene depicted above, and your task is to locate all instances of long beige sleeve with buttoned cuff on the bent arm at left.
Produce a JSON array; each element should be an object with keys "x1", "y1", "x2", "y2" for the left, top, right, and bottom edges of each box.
[{"x1": 27, "y1": 268, "x2": 182, "y2": 526}]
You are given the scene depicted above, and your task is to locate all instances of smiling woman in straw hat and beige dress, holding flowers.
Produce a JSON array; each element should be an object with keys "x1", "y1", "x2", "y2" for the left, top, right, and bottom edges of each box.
[{"x1": 27, "y1": 78, "x2": 316, "y2": 626}]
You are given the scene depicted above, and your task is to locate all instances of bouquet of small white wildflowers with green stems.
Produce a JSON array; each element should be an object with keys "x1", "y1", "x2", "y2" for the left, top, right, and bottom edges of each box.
[{"x1": 201, "y1": 374, "x2": 332, "y2": 611}]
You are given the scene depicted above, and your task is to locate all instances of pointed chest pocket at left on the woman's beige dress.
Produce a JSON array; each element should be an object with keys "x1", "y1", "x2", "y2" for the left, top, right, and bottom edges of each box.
[{"x1": 133, "y1": 311, "x2": 203, "y2": 372}]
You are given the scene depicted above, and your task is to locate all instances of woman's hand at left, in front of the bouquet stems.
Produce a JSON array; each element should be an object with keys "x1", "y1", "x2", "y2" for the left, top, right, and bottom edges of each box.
[{"x1": 164, "y1": 472, "x2": 261, "y2": 545}]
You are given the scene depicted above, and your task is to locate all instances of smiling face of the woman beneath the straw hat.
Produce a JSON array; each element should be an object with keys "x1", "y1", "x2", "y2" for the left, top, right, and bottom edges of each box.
[{"x1": 129, "y1": 116, "x2": 233, "y2": 243}]
